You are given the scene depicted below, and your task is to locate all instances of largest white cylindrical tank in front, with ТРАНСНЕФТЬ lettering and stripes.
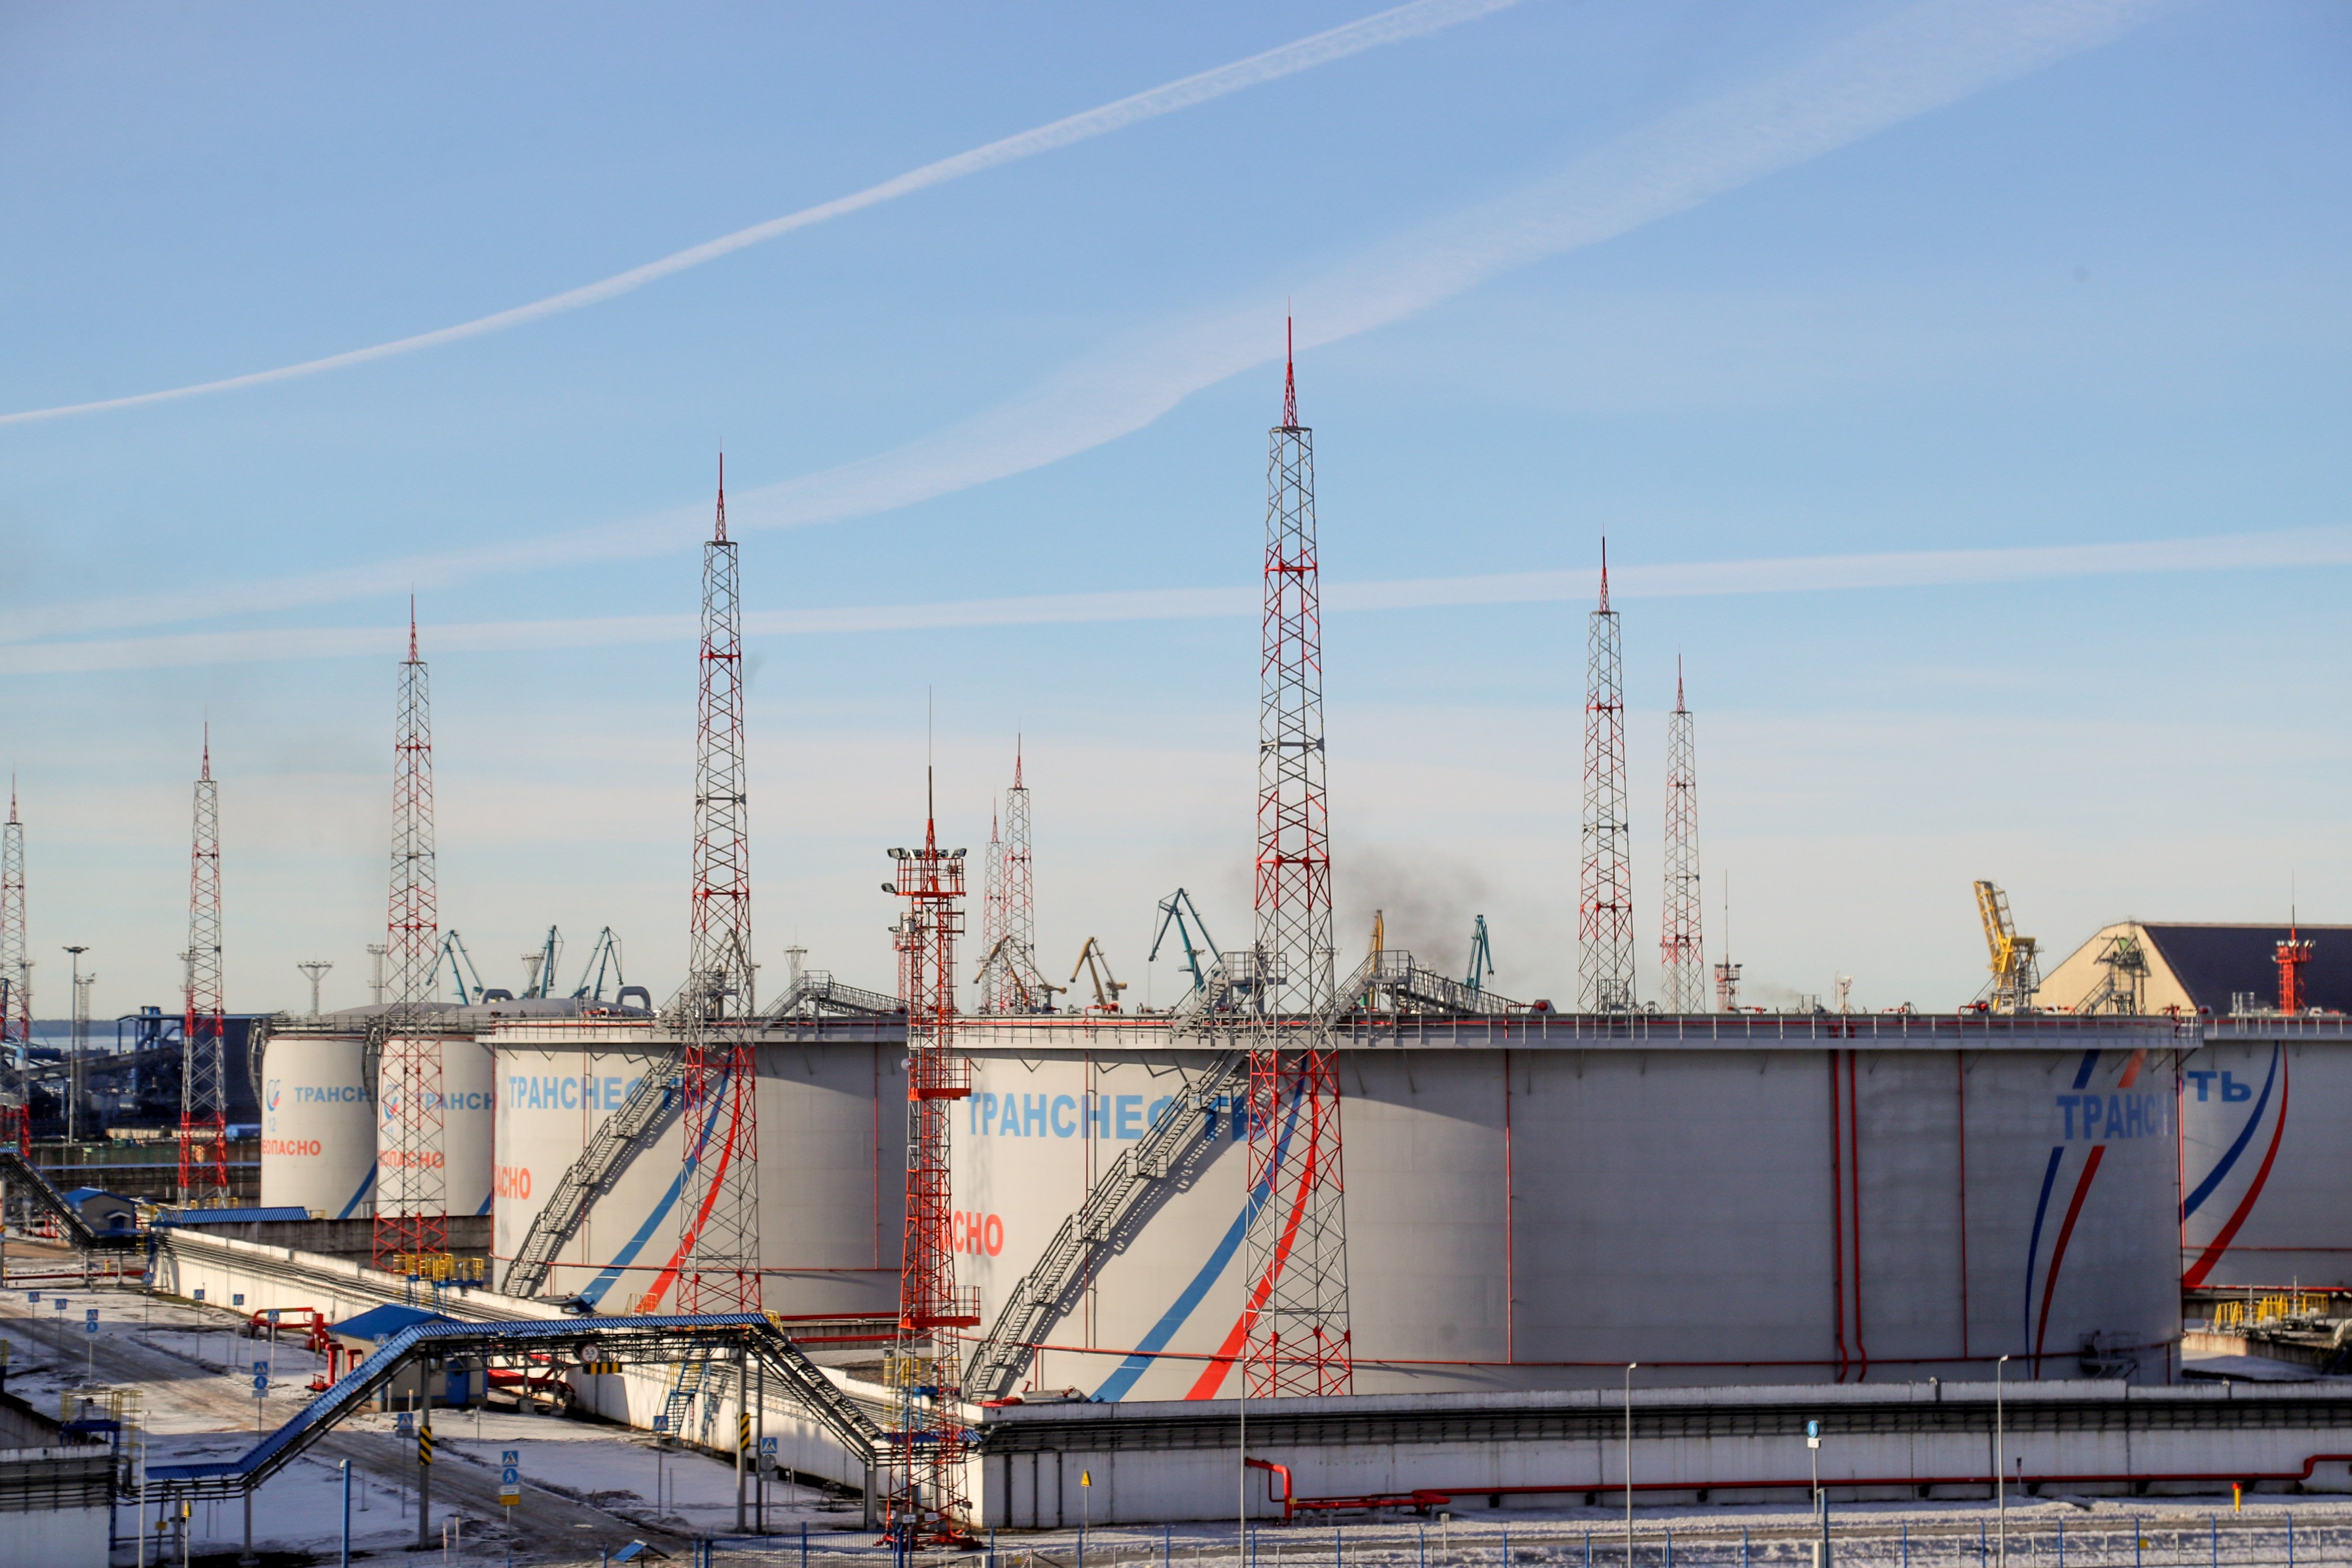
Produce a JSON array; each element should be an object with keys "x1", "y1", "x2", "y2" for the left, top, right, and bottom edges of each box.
[{"x1": 950, "y1": 1015, "x2": 2180, "y2": 1399}]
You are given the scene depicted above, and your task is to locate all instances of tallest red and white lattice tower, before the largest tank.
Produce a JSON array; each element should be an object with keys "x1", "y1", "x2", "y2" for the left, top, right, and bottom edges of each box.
[{"x1": 1242, "y1": 324, "x2": 1355, "y2": 1399}]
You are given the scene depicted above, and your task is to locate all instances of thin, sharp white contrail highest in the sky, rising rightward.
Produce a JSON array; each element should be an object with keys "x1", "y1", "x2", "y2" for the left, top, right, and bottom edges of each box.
[{"x1": 0, "y1": 0, "x2": 1519, "y2": 426}]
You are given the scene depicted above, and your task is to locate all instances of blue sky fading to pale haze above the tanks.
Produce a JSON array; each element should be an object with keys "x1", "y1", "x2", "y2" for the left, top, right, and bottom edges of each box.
[{"x1": 0, "y1": 0, "x2": 2352, "y2": 1013}]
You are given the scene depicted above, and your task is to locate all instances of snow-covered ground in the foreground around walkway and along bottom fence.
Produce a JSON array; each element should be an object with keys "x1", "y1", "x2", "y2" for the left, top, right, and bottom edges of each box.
[{"x1": 0, "y1": 1279, "x2": 2352, "y2": 1568}]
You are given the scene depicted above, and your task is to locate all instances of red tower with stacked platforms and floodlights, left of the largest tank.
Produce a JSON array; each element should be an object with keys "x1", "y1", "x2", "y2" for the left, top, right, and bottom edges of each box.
[{"x1": 885, "y1": 783, "x2": 981, "y2": 1549}]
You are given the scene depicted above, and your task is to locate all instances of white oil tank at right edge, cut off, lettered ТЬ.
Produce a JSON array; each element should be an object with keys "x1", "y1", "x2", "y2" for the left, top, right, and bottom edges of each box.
[{"x1": 2180, "y1": 1015, "x2": 2352, "y2": 1291}]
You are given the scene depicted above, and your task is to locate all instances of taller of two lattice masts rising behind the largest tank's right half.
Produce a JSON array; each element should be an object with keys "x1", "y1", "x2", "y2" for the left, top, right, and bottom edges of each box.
[{"x1": 1576, "y1": 538, "x2": 1632, "y2": 1013}]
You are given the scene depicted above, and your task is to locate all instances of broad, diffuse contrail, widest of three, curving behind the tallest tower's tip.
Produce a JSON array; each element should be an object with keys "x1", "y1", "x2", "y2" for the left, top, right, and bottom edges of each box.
[{"x1": 0, "y1": 0, "x2": 2178, "y2": 639}]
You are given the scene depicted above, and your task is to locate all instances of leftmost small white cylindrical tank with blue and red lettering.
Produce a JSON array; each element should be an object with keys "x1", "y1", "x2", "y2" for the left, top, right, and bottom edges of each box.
[{"x1": 261, "y1": 1018, "x2": 376, "y2": 1220}]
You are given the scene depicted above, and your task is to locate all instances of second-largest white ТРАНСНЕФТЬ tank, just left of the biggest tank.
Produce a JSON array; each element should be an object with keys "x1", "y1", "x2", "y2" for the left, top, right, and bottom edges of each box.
[{"x1": 487, "y1": 1020, "x2": 906, "y2": 1314}]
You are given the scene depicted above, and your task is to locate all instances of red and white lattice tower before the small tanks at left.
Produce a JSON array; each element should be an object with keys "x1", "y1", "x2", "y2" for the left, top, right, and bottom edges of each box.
[{"x1": 372, "y1": 600, "x2": 449, "y2": 1269}]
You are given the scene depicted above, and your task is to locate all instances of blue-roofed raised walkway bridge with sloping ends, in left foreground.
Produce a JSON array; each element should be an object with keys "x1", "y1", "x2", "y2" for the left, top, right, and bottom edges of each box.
[{"x1": 146, "y1": 1312, "x2": 882, "y2": 1497}]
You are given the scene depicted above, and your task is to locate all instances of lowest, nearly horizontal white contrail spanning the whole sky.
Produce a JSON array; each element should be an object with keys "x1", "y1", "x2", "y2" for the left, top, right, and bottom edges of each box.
[{"x1": 0, "y1": 527, "x2": 2323, "y2": 675}]
